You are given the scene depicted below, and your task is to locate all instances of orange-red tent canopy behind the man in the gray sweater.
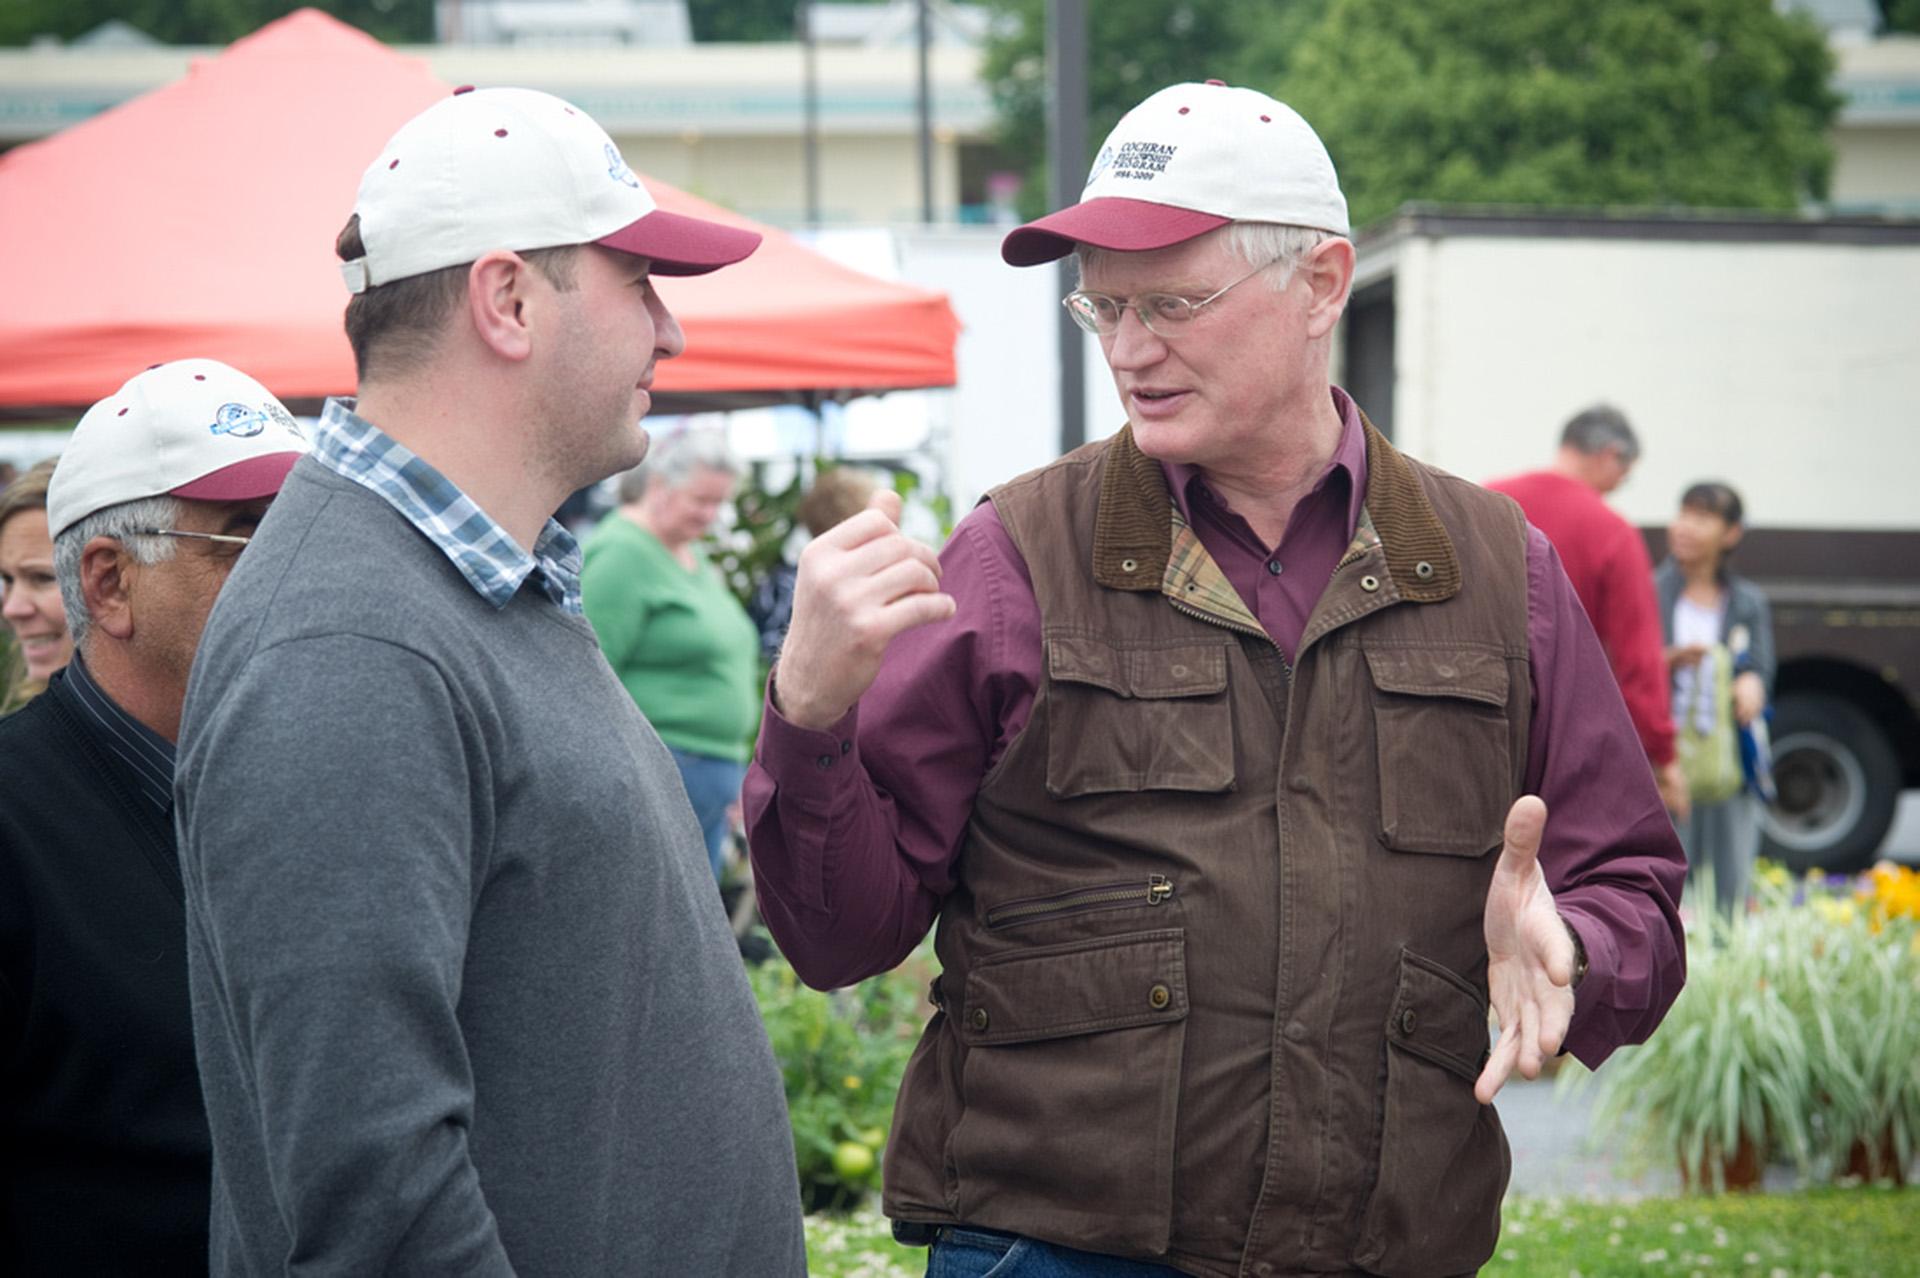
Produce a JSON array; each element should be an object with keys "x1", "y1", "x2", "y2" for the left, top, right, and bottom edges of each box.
[{"x1": 0, "y1": 10, "x2": 960, "y2": 416}]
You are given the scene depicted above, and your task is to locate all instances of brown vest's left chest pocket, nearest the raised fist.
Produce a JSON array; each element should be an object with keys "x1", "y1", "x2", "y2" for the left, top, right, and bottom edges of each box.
[{"x1": 1046, "y1": 635, "x2": 1235, "y2": 798}]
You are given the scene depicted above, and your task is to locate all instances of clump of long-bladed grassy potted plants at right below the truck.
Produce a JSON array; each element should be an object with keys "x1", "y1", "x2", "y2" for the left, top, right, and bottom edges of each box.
[{"x1": 1561, "y1": 867, "x2": 1920, "y2": 1188}]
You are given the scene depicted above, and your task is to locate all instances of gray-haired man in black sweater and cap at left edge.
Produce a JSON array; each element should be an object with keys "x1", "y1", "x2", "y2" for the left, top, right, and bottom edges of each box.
[{"x1": 0, "y1": 359, "x2": 305, "y2": 1274}]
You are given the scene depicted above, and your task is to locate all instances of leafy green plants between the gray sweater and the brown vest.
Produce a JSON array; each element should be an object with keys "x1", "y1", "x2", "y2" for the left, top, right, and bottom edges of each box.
[{"x1": 749, "y1": 946, "x2": 931, "y2": 1211}]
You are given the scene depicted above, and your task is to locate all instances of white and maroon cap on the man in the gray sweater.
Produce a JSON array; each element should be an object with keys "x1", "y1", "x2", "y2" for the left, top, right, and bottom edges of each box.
[{"x1": 340, "y1": 88, "x2": 760, "y2": 294}]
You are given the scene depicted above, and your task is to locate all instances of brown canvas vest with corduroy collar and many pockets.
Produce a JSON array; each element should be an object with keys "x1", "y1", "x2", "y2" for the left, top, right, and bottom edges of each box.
[{"x1": 885, "y1": 426, "x2": 1530, "y2": 1278}]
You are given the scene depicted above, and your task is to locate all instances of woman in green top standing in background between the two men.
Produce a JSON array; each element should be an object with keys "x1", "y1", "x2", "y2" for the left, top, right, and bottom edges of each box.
[{"x1": 580, "y1": 430, "x2": 760, "y2": 879}]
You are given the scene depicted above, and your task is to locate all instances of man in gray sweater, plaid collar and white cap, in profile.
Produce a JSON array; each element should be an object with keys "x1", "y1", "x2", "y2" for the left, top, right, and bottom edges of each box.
[{"x1": 177, "y1": 90, "x2": 806, "y2": 1278}]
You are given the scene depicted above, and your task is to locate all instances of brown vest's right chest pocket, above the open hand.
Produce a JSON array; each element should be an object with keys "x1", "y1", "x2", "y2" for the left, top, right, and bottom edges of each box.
[{"x1": 1367, "y1": 649, "x2": 1515, "y2": 856}]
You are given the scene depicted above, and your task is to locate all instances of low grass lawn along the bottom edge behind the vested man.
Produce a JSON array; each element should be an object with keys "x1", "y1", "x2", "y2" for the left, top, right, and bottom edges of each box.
[{"x1": 806, "y1": 1188, "x2": 1920, "y2": 1278}]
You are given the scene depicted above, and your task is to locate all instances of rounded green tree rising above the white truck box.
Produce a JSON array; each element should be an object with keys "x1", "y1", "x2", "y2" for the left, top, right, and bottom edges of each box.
[{"x1": 1250, "y1": 0, "x2": 1839, "y2": 226}]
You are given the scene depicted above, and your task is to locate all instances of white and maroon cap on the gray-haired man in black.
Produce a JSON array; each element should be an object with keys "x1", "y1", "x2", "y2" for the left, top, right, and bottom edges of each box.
[{"x1": 46, "y1": 359, "x2": 307, "y2": 537}]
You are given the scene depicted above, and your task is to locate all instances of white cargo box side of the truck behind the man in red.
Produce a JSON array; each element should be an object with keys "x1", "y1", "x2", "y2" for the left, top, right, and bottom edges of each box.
[{"x1": 1394, "y1": 236, "x2": 1920, "y2": 528}]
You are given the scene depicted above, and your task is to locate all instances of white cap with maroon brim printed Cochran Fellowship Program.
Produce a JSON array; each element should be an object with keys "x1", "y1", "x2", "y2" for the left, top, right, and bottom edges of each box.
[{"x1": 1000, "y1": 81, "x2": 1350, "y2": 267}]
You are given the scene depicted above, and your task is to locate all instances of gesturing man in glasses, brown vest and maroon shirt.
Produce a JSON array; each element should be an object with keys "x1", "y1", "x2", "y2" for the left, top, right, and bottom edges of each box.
[{"x1": 747, "y1": 81, "x2": 1684, "y2": 1278}]
